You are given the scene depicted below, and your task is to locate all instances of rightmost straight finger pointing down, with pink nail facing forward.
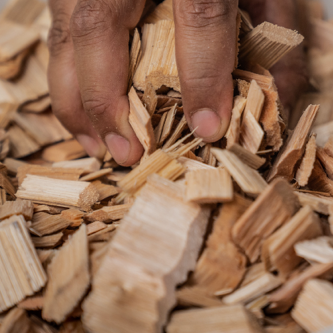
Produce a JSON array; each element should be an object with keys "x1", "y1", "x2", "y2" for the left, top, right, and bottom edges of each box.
[{"x1": 173, "y1": 0, "x2": 238, "y2": 142}]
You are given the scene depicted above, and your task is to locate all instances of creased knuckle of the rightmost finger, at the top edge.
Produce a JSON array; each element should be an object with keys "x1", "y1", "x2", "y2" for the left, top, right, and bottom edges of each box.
[{"x1": 178, "y1": 0, "x2": 237, "y2": 28}]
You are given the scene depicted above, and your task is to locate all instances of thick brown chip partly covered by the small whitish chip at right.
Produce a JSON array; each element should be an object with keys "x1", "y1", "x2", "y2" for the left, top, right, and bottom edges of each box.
[{"x1": 262, "y1": 206, "x2": 322, "y2": 278}]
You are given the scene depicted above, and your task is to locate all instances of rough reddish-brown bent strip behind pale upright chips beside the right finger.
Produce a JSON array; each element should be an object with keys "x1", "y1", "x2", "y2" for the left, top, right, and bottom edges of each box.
[{"x1": 233, "y1": 69, "x2": 283, "y2": 151}]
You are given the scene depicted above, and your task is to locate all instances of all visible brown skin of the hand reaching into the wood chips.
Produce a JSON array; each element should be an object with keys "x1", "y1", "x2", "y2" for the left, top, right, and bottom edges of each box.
[{"x1": 49, "y1": 0, "x2": 306, "y2": 166}]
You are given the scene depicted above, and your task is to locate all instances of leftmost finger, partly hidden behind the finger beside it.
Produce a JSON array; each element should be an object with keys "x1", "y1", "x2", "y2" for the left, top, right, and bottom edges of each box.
[{"x1": 48, "y1": 0, "x2": 105, "y2": 158}]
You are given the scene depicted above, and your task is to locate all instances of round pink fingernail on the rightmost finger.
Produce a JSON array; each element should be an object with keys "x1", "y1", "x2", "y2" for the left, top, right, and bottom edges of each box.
[{"x1": 191, "y1": 109, "x2": 221, "y2": 139}]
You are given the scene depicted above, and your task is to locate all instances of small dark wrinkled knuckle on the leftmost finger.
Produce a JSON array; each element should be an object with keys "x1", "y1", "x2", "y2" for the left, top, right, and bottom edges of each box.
[{"x1": 47, "y1": 11, "x2": 71, "y2": 55}]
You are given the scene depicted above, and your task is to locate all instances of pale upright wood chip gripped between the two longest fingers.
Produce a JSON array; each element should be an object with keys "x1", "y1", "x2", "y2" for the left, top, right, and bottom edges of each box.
[{"x1": 133, "y1": 20, "x2": 180, "y2": 91}]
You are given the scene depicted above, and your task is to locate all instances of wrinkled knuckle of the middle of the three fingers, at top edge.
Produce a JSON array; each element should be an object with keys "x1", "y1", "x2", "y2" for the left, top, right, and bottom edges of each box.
[{"x1": 71, "y1": 0, "x2": 119, "y2": 38}]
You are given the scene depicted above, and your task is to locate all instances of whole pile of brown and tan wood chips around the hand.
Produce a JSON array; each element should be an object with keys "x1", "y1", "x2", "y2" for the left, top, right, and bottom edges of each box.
[{"x1": 0, "y1": 0, "x2": 333, "y2": 333}]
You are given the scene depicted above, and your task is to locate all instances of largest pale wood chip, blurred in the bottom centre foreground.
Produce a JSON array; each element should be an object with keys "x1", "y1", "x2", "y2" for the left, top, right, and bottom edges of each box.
[{"x1": 83, "y1": 175, "x2": 210, "y2": 333}]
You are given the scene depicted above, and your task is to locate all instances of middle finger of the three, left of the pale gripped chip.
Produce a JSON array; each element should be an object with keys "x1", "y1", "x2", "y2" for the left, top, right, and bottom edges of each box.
[{"x1": 71, "y1": 0, "x2": 145, "y2": 166}]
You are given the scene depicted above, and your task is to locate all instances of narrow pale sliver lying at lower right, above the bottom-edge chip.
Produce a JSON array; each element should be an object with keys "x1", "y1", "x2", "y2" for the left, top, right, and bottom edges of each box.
[{"x1": 222, "y1": 273, "x2": 282, "y2": 304}]
